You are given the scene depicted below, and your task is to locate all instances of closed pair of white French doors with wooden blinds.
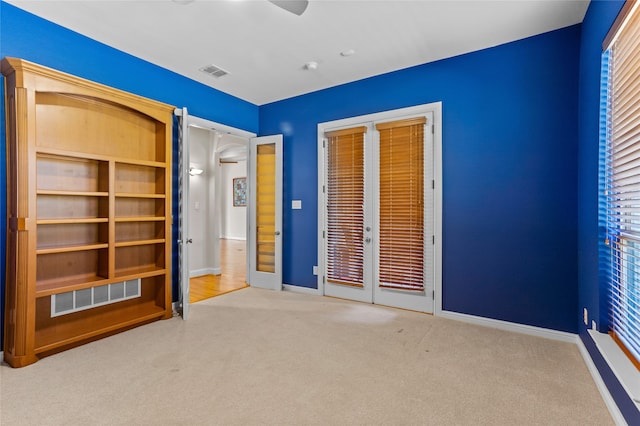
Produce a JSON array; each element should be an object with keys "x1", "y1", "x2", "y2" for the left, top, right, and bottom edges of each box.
[{"x1": 323, "y1": 113, "x2": 435, "y2": 312}]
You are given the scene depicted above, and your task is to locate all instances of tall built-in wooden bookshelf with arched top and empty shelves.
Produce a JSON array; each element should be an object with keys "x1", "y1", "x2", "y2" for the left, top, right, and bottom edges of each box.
[{"x1": 1, "y1": 58, "x2": 174, "y2": 367}]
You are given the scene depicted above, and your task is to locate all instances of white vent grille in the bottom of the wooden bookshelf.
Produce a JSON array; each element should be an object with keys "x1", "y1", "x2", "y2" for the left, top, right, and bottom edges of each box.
[{"x1": 51, "y1": 278, "x2": 141, "y2": 317}]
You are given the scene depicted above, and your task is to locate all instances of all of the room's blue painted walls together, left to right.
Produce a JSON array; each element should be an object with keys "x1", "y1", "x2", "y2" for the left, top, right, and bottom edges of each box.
[{"x1": 0, "y1": 1, "x2": 640, "y2": 424}]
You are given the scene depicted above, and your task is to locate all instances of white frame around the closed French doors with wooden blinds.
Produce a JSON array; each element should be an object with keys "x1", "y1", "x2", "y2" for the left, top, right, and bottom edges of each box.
[{"x1": 317, "y1": 102, "x2": 442, "y2": 315}]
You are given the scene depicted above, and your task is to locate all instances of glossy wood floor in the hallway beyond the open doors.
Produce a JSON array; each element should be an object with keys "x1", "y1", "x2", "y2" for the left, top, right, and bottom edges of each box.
[{"x1": 189, "y1": 239, "x2": 247, "y2": 303}]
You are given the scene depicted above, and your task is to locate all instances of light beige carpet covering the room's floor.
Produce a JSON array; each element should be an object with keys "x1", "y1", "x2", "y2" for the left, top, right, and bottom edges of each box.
[{"x1": 0, "y1": 288, "x2": 613, "y2": 426}]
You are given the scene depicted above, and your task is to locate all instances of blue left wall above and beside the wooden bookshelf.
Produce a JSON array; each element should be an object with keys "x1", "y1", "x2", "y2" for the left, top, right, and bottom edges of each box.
[{"x1": 0, "y1": 2, "x2": 258, "y2": 341}]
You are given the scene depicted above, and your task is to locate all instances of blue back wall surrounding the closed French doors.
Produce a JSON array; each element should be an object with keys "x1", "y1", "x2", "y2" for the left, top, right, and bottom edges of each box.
[{"x1": 260, "y1": 26, "x2": 580, "y2": 333}]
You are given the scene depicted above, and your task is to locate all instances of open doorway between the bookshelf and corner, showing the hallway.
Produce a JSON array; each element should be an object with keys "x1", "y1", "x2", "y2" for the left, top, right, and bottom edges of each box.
[{"x1": 188, "y1": 126, "x2": 248, "y2": 303}]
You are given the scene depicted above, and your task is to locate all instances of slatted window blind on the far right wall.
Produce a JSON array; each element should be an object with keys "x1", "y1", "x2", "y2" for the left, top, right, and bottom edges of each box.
[{"x1": 605, "y1": 1, "x2": 640, "y2": 366}]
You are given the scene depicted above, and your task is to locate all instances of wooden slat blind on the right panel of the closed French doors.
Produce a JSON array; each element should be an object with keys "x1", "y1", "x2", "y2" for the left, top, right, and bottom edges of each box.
[{"x1": 376, "y1": 117, "x2": 426, "y2": 291}]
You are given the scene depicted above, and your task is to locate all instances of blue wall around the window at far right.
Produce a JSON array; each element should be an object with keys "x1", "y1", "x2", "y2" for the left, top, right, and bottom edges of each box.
[{"x1": 577, "y1": 1, "x2": 640, "y2": 424}]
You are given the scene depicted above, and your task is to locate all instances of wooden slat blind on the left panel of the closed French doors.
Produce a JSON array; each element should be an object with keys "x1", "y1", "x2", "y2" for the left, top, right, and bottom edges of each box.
[{"x1": 325, "y1": 127, "x2": 367, "y2": 287}]
